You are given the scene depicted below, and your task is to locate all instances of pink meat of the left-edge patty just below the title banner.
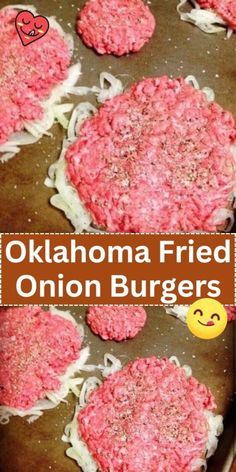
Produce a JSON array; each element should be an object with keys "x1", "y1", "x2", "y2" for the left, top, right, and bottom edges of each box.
[{"x1": 0, "y1": 307, "x2": 81, "y2": 410}]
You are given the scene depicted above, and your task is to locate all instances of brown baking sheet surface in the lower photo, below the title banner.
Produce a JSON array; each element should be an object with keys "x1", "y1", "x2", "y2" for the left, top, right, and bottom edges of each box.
[{"x1": 0, "y1": 307, "x2": 235, "y2": 472}]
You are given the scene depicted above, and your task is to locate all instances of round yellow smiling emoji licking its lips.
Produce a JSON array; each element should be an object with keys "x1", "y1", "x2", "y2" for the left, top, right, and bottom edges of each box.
[{"x1": 187, "y1": 298, "x2": 228, "y2": 339}]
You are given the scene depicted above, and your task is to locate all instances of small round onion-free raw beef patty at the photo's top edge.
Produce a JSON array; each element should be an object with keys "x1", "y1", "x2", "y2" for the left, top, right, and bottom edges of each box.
[{"x1": 77, "y1": 0, "x2": 155, "y2": 56}]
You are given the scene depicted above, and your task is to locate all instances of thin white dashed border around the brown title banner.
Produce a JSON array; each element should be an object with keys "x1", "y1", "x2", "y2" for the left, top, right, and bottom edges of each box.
[{"x1": 0, "y1": 232, "x2": 236, "y2": 308}]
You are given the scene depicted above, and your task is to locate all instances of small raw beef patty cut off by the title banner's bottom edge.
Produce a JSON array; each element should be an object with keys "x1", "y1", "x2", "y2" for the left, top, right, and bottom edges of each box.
[{"x1": 87, "y1": 306, "x2": 147, "y2": 341}]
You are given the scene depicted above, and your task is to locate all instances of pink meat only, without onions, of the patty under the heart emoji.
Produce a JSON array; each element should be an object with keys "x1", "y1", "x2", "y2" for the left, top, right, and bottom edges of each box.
[{"x1": 0, "y1": 9, "x2": 71, "y2": 144}]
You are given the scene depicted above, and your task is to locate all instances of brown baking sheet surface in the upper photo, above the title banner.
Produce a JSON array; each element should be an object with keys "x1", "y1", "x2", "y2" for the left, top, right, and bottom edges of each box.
[{"x1": 0, "y1": 0, "x2": 236, "y2": 232}]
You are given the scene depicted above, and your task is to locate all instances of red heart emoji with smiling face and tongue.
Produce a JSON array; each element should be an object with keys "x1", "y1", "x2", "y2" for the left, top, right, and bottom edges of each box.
[{"x1": 15, "y1": 10, "x2": 49, "y2": 46}]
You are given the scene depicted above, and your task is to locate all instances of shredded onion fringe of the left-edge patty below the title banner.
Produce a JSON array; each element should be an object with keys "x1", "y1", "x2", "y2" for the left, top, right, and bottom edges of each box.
[{"x1": 0, "y1": 305, "x2": 90, "y2": 424}]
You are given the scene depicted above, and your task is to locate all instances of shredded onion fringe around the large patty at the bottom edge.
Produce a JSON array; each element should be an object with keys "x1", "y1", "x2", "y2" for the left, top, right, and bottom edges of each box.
[{"x1": 62, "y1": 354, "x2": 223, "y2": 472}]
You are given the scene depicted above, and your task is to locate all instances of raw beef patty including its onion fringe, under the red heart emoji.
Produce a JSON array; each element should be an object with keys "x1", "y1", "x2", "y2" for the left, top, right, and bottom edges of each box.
[{"x1": 0, "y1": 5, "x2": 80, "y2": 161}]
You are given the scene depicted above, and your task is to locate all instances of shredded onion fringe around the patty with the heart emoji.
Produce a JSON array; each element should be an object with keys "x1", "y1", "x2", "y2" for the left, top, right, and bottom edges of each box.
[{"x1": 0, "y1": 4, "x2": 81, "y2": 163}]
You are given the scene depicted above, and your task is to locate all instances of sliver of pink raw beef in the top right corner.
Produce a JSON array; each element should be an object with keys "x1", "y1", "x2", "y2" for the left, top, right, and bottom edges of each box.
[{"x1": 197, "y1": 0, "x2": 236, "y2": 30}]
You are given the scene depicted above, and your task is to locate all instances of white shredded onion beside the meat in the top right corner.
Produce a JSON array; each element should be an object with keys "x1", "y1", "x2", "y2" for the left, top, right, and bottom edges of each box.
[{"x1": 177, "y1": 0, "x2": 230, "y2": 38}]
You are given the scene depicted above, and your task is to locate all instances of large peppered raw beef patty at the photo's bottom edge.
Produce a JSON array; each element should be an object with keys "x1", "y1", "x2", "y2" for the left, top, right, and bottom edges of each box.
[{"x1": 77, "y1": 357, "x2": 218, "y2": 472}]
